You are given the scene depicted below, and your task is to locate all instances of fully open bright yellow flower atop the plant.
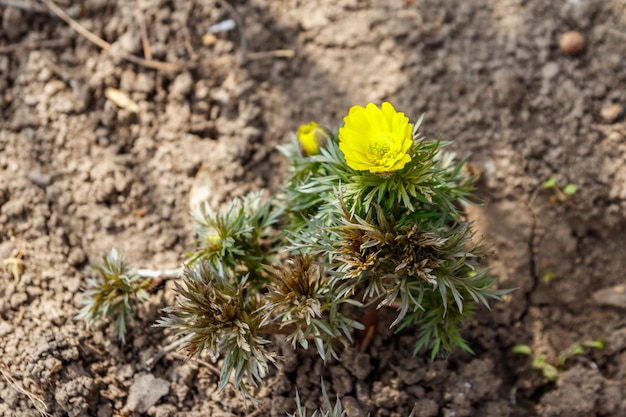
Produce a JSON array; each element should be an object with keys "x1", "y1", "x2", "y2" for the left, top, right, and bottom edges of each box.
[{"x1": 339, "y1": 102, "x2": 413, "y2": 174}]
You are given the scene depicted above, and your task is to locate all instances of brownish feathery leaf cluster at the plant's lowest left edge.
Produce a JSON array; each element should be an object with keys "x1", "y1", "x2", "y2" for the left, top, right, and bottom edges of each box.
[{"x1": 157, "y1": 261, "x2": 275, "y2": 398}]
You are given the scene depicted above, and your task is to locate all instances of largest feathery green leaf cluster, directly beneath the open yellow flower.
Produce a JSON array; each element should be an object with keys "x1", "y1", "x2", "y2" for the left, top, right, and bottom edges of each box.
[{"x1": 284, "y1": 119, "x2": 507, "y2": 357}]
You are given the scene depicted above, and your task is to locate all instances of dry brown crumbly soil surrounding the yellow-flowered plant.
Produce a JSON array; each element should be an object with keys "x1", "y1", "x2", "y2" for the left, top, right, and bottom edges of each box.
[{"x1": 0, "y1": 0, "x2": 626, "y2": 417}]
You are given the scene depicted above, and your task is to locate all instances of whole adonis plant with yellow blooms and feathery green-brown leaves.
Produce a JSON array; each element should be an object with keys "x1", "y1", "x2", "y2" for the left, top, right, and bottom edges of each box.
[{"x1": 82, "y1": 103, "x2": 504, "y2": 404}]
